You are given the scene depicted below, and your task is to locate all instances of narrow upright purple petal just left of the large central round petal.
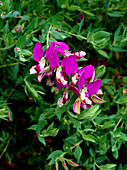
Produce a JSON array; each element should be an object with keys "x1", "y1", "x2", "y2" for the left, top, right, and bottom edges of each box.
[{"x1": 50, "y1": 51, "x2": 59, "y2": 71}]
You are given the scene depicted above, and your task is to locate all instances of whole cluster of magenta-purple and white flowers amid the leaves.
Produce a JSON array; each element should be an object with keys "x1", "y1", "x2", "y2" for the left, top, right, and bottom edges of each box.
[{"x1": 30, "y1": 41, "x2": 105, "y2": 114}]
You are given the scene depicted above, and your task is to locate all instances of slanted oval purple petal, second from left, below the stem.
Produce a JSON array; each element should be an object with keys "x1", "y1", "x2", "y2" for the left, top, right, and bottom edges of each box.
[{"x1": 45, "y1": 43, "x2": 55, "y2": 61}]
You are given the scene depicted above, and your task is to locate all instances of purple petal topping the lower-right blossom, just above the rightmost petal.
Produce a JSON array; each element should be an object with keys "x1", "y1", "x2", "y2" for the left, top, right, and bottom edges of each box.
[{"x1": 79, "y1": 65, "x2": 94, "y2": 79}]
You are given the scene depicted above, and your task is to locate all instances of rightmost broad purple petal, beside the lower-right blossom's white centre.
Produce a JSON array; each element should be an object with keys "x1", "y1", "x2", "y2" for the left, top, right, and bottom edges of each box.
[{"x1": 86, "y1": 79, "x2": 102, "y2": 95}]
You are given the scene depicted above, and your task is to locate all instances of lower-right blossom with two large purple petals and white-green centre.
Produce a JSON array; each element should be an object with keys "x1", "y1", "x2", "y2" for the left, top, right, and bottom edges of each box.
[{"x1": 69, "y1": 65, "x2": 105, "y2": 114}]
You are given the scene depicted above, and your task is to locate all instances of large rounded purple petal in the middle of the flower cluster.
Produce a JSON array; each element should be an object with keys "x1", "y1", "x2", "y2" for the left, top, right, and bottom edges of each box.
[{"x1": 61, "y1": 55, "x2": 78, "y2": 76}]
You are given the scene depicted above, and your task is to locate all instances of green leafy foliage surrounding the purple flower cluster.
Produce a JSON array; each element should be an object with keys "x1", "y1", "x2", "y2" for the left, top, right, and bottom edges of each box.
[{"x1": 0, "y1": 0, "x2": 127, "y2": 170}]
